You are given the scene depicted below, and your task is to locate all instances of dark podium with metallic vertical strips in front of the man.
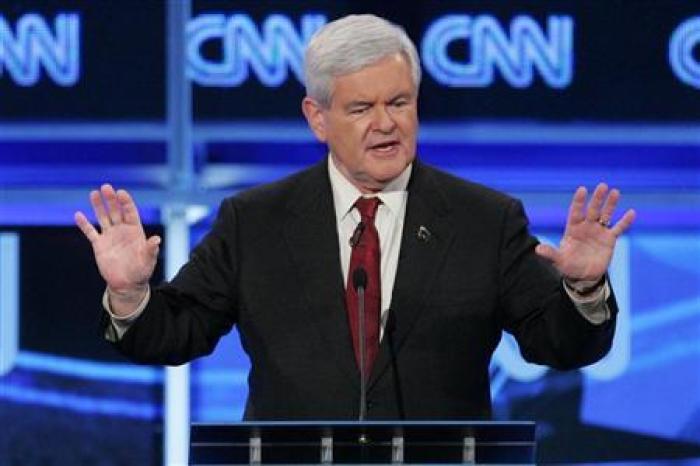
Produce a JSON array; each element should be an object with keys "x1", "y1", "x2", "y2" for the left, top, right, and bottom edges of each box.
[{"x1": 190, "y1": 421, "x2": 535, "y2": 466}]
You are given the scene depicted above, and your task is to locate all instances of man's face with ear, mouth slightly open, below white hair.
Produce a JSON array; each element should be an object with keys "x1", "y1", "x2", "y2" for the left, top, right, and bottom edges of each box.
[{"x1": 303, "y1": 53, "x2": 418, "y2": 193}]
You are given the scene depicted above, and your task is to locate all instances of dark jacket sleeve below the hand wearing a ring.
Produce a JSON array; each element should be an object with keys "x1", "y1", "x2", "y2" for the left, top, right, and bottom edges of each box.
[{"x1": 499, "y1": 200, "x2": 617, "y2": 369}]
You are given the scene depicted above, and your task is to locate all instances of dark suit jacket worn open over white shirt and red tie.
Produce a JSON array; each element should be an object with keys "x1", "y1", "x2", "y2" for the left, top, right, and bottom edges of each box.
[{"x1": 117, "y1": 160, "x2": 617, "y2": 420}]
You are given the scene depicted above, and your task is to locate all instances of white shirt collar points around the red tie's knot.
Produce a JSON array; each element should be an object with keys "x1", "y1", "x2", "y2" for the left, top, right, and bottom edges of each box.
[{"x1": 328, "y1": 154, "x2": 413, "y2": 222}]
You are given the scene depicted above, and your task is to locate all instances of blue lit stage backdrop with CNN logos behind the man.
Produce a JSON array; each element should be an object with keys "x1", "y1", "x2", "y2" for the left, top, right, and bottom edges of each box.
[{"x1": 0, "y1": 0, "x2": 700, "y2": 465}]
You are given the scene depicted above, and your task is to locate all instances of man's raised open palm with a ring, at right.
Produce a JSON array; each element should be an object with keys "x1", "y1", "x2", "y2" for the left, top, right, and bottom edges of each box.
[{"x1": 536, "y1": 183, "x2": 636, "y2": 282}]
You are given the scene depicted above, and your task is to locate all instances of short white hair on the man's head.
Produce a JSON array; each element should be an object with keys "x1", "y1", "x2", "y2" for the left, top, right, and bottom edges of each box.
[{"x1": 304, "y1": 15, "x2": 421, "y2": 108}]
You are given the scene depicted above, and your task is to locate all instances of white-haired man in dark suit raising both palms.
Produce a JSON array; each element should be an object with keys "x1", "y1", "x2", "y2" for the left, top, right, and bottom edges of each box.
[{"x1": 76, "y1": 15, "x2": 634, "y2": 420}]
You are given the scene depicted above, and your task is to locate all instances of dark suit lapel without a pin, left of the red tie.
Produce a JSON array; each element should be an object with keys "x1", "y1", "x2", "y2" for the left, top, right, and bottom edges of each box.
[{"x1": 285, "y1": 159, "x2": 359, "y2": 386}]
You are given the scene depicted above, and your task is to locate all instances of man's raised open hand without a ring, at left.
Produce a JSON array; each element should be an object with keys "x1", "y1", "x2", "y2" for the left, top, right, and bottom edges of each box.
[{"x1": 75, "y1": 184, "x2": 161, "y2": 317}]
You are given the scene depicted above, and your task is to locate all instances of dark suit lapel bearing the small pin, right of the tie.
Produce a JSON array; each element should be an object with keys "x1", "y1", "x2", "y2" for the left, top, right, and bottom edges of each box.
[{"x1": 368, "y1": 161, "x2": 454, "y2": 389}]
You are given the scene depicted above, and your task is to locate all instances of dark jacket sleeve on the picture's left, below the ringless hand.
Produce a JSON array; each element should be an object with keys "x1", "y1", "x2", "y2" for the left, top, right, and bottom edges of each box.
[{"x1": 108, "y1": 199, "x2": 238, "y2": 365}]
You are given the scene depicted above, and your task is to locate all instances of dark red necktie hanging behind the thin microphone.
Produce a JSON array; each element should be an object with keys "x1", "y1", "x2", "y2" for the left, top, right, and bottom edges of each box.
[{"x1": 345, "y1": 197, "x2": 382, "y2": 377}]
